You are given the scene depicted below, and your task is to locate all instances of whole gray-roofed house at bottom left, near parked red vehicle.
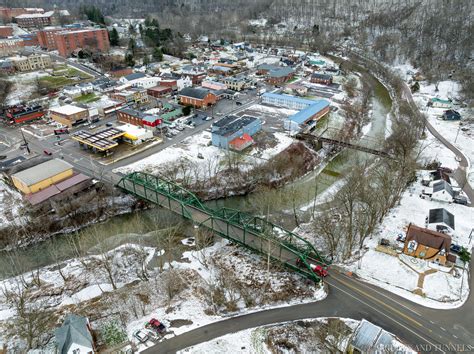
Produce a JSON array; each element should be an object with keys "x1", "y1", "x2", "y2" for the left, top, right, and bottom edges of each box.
[{"x1": 54, "y1": 314, "x2": 95, "y2": 354}]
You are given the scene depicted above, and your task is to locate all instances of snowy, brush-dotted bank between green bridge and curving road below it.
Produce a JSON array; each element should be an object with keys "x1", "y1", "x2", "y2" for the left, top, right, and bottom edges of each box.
[{"x1": 127, "y1": 241, "x2": 327, "y2": 350}]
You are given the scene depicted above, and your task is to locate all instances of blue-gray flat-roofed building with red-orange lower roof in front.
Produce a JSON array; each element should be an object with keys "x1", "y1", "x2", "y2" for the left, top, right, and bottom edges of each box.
[{"x1": 212, "y1": 116, "x2": 262, "y2": 150}]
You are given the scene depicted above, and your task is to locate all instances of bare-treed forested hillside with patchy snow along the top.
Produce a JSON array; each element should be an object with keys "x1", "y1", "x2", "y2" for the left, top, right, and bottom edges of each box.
[{"x1": 4, "y1": 0, "x2": 474, "y2": 101}]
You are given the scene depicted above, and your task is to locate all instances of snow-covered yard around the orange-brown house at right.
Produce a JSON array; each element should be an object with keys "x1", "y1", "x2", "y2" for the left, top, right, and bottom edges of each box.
[{"x1": 346, "y1": 173, "x2": 474, "y2": 308}]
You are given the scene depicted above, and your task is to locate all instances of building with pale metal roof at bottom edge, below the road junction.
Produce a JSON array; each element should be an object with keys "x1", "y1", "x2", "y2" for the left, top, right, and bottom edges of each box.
[{"x1": 346, "y1": 319, "x2": 395, "y2": 354}]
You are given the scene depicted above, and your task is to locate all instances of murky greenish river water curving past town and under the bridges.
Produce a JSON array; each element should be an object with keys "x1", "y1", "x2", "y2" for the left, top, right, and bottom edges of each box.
[{"x1": 0, "y1": 70, "x2": 391, "y2": 278}]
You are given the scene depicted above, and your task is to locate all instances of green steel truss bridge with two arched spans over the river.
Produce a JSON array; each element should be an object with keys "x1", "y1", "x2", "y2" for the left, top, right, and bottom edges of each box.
[{"x1": 117, "y1": 172, "x2": 329, "y2": 282}]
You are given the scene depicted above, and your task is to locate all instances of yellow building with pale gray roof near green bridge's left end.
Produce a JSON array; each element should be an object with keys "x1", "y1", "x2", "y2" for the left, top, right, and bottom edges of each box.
[{"x1": 11, "y1": 159, "x2": 73, "y2": 194}]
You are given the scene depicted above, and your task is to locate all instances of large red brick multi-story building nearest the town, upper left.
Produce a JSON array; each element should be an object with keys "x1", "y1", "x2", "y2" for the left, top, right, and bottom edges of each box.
[{"x1": 54, "y1": 28, "x2": 110, "y2": 57}]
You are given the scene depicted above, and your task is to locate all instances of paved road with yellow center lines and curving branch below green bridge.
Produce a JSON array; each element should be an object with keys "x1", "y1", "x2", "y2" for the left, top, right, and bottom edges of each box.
[{"x1": 144, "y1": 266, "x2": 474, "y2": 354}]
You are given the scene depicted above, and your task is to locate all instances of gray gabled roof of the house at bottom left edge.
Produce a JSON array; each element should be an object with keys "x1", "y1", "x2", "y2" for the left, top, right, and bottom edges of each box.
[{"x1": 55, "y1": 314, "x2": 93, "y2": 354}]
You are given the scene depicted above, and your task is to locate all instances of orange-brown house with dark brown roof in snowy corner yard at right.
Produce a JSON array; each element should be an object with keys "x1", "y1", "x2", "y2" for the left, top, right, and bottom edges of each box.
[{"x1": 403, "y1": 224, "x2": 451, "y2": 265}]
